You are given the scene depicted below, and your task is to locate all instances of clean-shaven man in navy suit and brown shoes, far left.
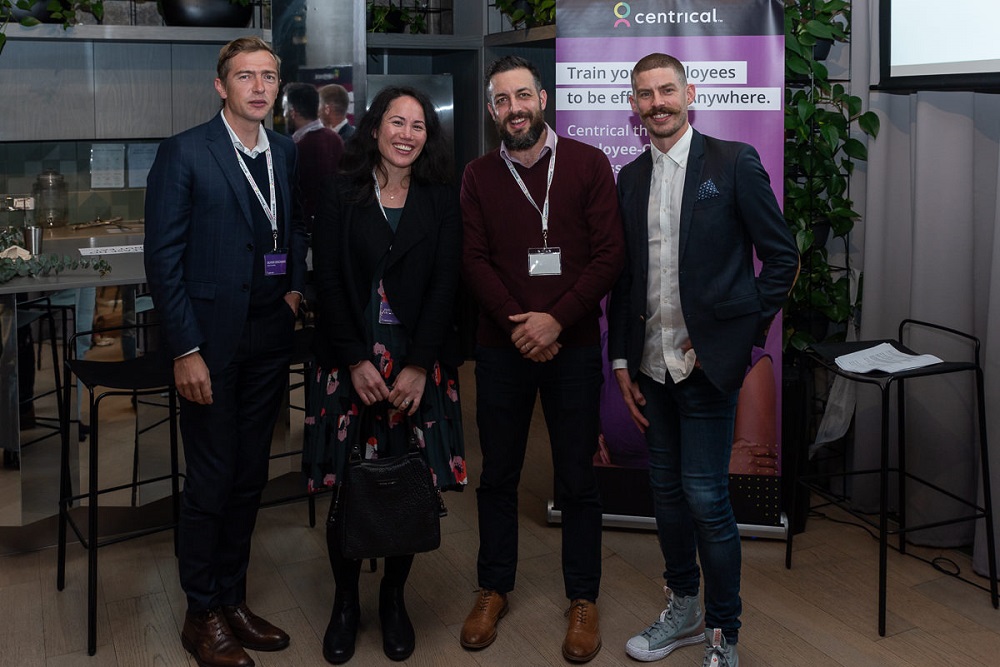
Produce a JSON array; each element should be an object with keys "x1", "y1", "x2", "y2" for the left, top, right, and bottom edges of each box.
[{"x1": 145, "y1": 37, "x2": 306, "y2": 667}]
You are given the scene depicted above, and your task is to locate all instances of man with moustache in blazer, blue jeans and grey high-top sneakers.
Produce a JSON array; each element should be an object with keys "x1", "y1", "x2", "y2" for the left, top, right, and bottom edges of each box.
[{"x1": 608, "y1": 54, "x2": 798, "y2": 667}]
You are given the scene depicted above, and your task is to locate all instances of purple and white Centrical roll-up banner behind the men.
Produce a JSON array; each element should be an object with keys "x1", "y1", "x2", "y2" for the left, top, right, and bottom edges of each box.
[{"x1": 554, "y1": 0, "x2": 784, "y2": 535}]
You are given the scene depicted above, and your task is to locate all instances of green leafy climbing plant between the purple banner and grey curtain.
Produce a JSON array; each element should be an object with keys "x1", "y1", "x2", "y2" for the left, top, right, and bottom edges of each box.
[{"x1": 784, "y1": 0, "x2": 879, "y2": 350}]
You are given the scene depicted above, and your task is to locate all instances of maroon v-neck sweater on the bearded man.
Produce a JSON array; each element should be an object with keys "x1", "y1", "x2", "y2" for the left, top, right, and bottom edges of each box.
[{"x1": 462, "y1": 137, "x2": 625, "y2": 347}]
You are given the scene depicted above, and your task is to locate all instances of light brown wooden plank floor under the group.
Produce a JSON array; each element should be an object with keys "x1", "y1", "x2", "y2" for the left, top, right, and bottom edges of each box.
[{"x1": 0, "y1": 360, "x2": 1000, "y2": 667}]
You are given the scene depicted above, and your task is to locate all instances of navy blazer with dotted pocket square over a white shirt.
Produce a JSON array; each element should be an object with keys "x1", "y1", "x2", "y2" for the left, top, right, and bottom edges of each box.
[{"x1": 608, "y1": 130, "x2": 799, "y2": 391}]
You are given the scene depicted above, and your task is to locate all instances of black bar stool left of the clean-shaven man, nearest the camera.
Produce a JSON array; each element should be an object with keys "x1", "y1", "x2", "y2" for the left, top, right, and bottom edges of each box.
[{"x1": 56, "y1": 325, "x2": 181, "y2": 655}]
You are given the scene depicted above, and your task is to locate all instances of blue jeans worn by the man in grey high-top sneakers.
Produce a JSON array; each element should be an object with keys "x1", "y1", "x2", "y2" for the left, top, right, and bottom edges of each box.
[{"x1": 638, "y1": 369, "x2": 742, "y2": 643}]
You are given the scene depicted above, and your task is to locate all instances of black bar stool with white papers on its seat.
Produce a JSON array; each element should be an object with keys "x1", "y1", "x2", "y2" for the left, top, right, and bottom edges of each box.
[{"x1": 785, "y1": 319, "x2": 1000, "y2": 637}]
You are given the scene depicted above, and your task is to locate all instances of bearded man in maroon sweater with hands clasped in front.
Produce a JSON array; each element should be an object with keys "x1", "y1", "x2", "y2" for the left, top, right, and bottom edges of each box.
[{"x1": 461, "y1": 56, "x2": 624, "y2": 662}]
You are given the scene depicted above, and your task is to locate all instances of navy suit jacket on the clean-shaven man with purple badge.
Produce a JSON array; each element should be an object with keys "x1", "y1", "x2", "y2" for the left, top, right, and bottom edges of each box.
[{"x1": 144, "y1": 115, "x2": 308, "y2": 373}]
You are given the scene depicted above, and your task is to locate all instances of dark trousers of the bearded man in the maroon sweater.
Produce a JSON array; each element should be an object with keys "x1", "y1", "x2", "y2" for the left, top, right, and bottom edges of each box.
[{"x1": 476, "y1": 346, "x2": 603, "y2": 601}]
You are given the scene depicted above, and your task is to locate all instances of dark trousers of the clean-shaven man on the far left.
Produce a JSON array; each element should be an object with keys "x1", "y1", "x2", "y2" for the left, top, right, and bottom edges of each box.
[{"x1": 177, "y1": 302, "x2": 294, "y2": 612}]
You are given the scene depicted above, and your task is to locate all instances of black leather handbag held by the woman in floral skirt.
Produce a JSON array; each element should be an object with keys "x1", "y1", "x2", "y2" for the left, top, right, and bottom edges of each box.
[{"x1": 335, "y1": 409, "x2": 442, "y2": 559}]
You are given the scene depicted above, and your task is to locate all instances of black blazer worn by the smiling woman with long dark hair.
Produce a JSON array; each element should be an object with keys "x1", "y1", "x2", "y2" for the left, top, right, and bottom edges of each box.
[{"x1": 312, "y1": 176, "x2": 462, "y2": 371}]
